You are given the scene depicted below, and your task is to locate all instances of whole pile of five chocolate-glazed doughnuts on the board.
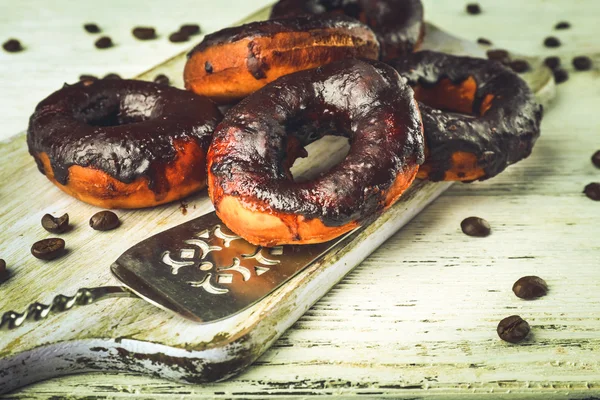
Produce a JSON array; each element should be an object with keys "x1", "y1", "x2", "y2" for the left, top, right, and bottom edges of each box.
[{"x1": 27, "y1": 0, "x2": 542, "y2": 246}]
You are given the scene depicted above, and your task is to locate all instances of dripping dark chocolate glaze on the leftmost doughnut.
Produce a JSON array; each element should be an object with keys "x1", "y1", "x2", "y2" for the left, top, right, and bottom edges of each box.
[{"x1": 27, "y1": 79, "x2": 222, "y2": 192}]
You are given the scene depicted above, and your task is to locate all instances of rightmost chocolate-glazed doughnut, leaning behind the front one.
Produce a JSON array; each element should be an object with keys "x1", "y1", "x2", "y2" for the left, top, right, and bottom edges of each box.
[{"x1": 389, "y1": 51, "x2": 542, "y2": 182}]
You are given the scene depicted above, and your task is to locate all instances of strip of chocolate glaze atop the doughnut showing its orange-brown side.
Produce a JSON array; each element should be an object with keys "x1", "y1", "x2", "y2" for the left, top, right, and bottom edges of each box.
[{"x1": 187, "y1": 15, "x2": 366, "y2": 58}]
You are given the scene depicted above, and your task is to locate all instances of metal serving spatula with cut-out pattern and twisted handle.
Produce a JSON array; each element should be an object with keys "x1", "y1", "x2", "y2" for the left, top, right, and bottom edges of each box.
[{"x1": 0, "y1": 212, "x2": 355, "y2": 329}]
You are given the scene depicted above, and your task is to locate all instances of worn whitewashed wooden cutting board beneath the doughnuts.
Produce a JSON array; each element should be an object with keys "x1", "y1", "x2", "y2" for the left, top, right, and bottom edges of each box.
[{"x1": 0, "y1": 4, "x2": 554, "y2": 393}]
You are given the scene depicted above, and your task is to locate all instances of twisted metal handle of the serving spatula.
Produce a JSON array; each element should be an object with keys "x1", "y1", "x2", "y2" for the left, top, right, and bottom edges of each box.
[{"x1": 0, "y1": 286, "x2": 138, "y2": 331}]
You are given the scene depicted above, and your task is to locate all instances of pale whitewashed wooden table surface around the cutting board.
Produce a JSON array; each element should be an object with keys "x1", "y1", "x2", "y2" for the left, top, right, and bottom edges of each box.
[{"x1": 0, "y1": 0, "x2": 600, "y2": 398}]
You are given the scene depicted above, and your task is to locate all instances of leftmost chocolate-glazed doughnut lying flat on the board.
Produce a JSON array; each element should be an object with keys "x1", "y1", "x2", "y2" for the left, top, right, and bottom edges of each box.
[{"x1": 27, "y1": 79, "x2": 222, "y2": 208}]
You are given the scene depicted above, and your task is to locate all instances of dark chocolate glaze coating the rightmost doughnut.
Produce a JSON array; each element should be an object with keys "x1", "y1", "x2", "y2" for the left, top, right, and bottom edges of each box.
[{"x1": 390, "y1": 51, "x2": 542, "y2": 181}]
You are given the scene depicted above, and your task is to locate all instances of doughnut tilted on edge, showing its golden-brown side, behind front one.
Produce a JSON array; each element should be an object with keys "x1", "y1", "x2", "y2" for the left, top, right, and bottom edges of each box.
[{"x1": 184, "y1": 15, "x2": 379, "y2": 104}]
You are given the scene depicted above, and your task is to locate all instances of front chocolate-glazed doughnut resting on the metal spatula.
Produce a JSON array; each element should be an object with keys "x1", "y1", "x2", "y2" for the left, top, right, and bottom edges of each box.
[{"x1": 207, "y1": 59, "x2": 424, "y2": 246}]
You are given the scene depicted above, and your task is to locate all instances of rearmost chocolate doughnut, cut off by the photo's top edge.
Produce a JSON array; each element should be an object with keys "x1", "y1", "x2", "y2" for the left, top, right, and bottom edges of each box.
[{"x1": 271, "y1": 0, "x2": 425, "y2": 61}]
